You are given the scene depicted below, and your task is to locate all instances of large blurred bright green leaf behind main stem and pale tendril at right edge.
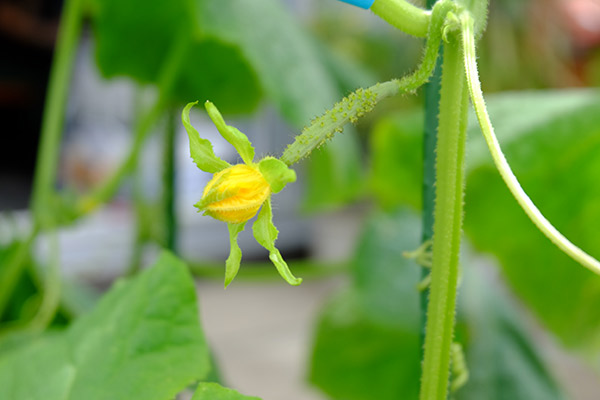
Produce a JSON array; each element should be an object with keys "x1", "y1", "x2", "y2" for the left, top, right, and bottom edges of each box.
[{"x1": 372, "y1": 90, "x2": 600, "y2": 351}]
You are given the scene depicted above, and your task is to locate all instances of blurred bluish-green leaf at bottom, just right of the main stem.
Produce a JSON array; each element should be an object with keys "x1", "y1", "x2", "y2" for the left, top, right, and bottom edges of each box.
[{"x1": 455, "y1": 252, "x2": 565, "y2": 400}]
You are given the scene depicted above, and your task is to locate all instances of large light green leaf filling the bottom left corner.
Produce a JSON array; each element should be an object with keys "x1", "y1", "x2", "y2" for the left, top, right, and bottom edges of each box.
[{"x1": 0, "y1": 253, "x2": 210, "y2": 400}]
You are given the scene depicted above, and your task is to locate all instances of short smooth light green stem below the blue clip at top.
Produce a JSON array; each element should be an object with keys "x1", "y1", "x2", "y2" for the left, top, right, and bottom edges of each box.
[{"x1": 371, "y1": 0, "x2": 431, "y2": 37}]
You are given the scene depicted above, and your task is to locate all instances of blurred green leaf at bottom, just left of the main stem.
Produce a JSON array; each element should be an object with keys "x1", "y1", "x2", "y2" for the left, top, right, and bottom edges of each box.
[{"x1": 310, "y1": 212, "x2": 421, "y2": 400}]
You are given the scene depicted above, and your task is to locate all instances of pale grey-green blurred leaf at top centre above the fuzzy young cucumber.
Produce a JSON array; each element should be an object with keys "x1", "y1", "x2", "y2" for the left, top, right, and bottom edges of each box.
[{"x1": 196, "y1": 0, "x2": 338, "y2": 127}]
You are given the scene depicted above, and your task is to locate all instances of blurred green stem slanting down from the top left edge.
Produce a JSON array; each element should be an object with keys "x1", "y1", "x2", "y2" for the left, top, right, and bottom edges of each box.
[{"x1": 32, "y1": 0, "x2": 83, "y2": 229}]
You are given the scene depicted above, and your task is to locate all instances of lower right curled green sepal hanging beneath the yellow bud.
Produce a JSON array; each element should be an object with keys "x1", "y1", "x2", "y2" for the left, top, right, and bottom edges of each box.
[{"x1": 252, "y1": 198, "x2": 302, "y2": 286}]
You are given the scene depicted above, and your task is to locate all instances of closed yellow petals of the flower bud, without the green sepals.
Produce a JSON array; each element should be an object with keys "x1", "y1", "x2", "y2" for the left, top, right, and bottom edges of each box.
[{"x1": 197, "y1": 164, "x2": 271, "y2": 224}]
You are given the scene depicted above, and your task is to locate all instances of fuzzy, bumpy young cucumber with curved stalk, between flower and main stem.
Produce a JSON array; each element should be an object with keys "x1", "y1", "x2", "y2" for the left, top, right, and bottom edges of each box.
[{"x1": 281, "y1": 0, "x2": 455, "y2": 165}]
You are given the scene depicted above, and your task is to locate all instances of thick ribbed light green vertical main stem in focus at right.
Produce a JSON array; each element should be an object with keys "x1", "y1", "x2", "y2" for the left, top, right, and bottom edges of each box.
[{"x1": 420, "y1": 34, "x2": 468, "y2": 400}]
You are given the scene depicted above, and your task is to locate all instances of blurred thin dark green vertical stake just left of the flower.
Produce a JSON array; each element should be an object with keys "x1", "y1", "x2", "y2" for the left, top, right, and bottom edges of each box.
[{"x1": 162, "y1": 109, "x2": 178, "y2": 253}]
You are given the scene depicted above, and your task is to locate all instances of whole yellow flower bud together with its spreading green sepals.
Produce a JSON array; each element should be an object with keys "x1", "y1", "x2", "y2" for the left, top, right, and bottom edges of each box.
[{"x1": 181, "y1": 101, "x2": 302, "y2": 287}]
